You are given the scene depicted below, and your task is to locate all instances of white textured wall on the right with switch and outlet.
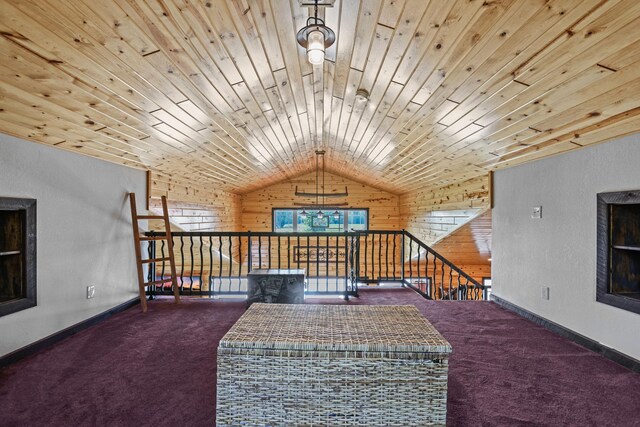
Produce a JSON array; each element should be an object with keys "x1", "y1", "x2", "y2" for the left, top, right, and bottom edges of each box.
[{"x1": 492, "y1": 134, "x2": 640, "y2": 359}]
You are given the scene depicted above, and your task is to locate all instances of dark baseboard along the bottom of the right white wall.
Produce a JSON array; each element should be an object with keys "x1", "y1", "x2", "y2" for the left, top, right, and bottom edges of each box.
[{"x1": 491, "y1": 294, "x2": 640, "y2": 372}]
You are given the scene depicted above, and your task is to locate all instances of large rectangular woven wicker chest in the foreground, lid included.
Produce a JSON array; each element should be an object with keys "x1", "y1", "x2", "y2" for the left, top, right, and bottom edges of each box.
[{"x1": 216, "y1": 303, "x2": 451, "y2": 427}]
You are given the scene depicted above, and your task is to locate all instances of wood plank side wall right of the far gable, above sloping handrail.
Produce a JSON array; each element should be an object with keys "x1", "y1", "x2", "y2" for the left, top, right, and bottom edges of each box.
[{"x1": 400, "y1": 176, "x2": 489, "y2": 245}]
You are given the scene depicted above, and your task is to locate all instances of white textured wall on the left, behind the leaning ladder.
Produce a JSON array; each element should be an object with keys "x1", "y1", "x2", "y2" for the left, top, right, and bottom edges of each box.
[{"x1": 0, "y1": 134, "x2": 146, "y2": 356}]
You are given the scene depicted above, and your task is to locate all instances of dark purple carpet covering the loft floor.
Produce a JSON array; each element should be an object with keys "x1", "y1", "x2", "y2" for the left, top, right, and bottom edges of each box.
[{"x1": 0, "y1": 288, "x2": 640, "y2": 427}]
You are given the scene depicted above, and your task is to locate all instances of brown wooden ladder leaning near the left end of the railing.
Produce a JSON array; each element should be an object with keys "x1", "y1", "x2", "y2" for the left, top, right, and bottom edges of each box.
[{"x1": 129, "y1": 193, "x2": 180, "y2": 313}]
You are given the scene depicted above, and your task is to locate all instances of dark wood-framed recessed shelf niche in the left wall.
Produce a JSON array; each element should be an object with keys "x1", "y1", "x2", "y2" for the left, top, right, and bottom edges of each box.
[{"x1": 0, "y1": 197, "x2": 37, "y2": 316}]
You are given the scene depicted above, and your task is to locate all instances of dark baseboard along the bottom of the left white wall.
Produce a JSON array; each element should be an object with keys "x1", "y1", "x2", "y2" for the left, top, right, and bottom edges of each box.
[{"x1": 0, "y1": 297, "x2": 140, "y2": 368}]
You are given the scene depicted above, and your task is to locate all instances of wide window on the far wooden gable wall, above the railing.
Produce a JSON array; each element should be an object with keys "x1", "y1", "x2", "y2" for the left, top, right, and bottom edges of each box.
[{"x1": 273, "y1": 208, "x2": 369, "y2": 233}]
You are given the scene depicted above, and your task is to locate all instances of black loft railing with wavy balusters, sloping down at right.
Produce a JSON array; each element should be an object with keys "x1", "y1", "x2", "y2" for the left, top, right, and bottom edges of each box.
[{"x1": 147, "y1": 230, "x2": 486, "y2": 300}]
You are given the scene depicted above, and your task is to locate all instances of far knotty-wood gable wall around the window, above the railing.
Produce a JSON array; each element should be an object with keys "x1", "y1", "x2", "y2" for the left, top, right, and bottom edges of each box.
[{"x1": 241, "y1": 172, "x2": 403, "y2": 231}]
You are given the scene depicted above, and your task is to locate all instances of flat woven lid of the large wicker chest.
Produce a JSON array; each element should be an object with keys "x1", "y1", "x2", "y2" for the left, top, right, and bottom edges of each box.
[{"x1": 219, "y1": 303, "x2": 451, "y2": 358}]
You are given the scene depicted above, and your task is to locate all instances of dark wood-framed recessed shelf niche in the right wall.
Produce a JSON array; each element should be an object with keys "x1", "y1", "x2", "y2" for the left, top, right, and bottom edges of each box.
[{"x1": 596, "y1": 191, "x2": 640, "y2": 313}]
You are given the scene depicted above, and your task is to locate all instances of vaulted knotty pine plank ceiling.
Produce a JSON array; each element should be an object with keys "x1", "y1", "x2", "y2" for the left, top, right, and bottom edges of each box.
[{"x1": 0, "y1": 0, "x2": 640, "y2": 193}]
